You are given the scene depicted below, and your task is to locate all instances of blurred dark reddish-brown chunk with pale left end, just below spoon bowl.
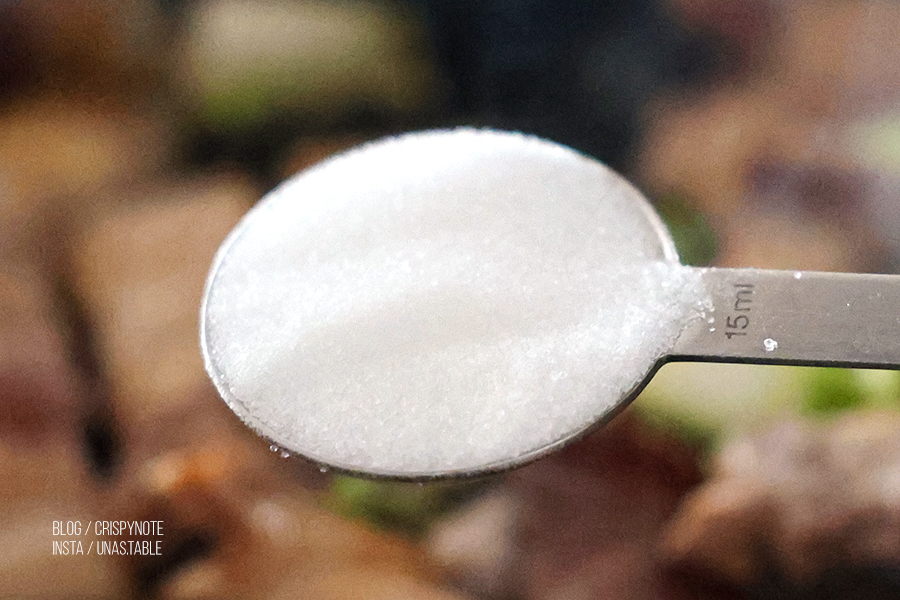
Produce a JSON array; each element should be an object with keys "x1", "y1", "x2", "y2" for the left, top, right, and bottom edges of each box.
[{"x1": 430, "y1": 412, "x2": 702, "y2": 600}]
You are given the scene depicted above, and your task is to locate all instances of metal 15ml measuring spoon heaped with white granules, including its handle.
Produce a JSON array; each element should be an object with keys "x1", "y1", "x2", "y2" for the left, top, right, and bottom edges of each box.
[{"x1": 201, "y1": 129, "x2": 900, "y2": 479}]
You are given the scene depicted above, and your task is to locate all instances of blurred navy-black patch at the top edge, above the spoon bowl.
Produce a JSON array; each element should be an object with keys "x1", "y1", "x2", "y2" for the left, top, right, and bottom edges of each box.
[{"x1": 409, "y1": 0, "x2": 718, "y2": 167}]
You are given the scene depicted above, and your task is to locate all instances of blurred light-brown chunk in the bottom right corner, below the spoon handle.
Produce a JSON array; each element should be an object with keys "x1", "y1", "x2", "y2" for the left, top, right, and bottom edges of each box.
[{"x1": 661, "y1": 413, "x2": 900, "y2": 598}]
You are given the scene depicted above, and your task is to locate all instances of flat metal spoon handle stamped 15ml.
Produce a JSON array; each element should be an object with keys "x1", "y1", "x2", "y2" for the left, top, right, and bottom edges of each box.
[{"x1": 668, "y1": 269, "x2": 900, "y2": 369}]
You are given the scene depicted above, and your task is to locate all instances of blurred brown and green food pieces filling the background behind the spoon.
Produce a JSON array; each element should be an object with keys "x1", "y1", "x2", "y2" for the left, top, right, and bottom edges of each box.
[{"x1": 0, "y1": 0, "x2": 900, "y2": 600}]
